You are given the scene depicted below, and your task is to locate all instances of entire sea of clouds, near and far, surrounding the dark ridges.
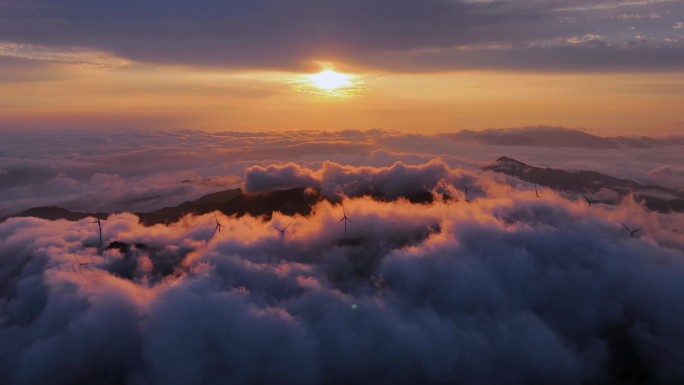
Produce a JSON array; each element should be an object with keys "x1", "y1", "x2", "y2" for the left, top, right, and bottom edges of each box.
[{"x1": 0, "y1": 127, "x2": 684, "y2": 384}]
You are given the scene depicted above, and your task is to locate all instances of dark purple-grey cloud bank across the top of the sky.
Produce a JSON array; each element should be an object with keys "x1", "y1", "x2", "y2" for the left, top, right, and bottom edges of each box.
[{"x1": 0, "y1": 0, "x2": 684, "y2": 72}]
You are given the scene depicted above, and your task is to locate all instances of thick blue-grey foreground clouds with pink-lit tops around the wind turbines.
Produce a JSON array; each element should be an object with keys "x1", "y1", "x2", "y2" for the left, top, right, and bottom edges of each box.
[{"x1": 0, "y1": 164, "x2": 684, "y2": 384}]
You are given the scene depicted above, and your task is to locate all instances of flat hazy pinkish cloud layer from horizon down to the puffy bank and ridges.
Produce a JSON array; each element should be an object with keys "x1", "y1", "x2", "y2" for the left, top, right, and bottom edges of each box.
[{"x1": 0, "y1": 130, "x2": 684, "y2": 216}]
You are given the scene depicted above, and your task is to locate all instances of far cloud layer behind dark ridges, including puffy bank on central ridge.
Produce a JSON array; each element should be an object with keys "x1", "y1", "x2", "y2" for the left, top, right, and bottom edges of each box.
[{"x1": 0, "y1": 127, "x2": 684, "y2": 216}]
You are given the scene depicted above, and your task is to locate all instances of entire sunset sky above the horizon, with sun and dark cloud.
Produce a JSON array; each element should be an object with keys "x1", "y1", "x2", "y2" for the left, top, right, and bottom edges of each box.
[{"x1": 0, "y1": 0, "x2": 684, "y2": 135}]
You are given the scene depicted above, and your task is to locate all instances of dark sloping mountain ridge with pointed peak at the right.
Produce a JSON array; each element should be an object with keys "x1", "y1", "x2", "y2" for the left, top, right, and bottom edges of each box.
[{"x1": 484, "y1": 156, "x2": 684, "y2": 212}]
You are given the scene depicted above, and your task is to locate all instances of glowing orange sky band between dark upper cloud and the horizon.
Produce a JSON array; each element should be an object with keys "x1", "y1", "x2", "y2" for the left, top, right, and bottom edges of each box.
[{"x1": 0, "y1": 60, "x2": 684, "y2": 135}]
